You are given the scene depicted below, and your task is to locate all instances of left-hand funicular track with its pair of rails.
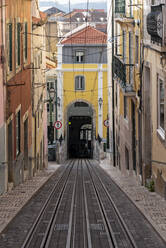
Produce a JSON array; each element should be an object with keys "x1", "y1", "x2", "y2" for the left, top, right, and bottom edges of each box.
[{"x1": 21, "y1": 161, "x2": 74, "y2": 248}]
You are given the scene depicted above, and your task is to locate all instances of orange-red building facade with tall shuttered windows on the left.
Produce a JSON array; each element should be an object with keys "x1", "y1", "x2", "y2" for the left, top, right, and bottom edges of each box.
[{"x1": 5, "y1": 0, "x2": 32, "y2": 188}]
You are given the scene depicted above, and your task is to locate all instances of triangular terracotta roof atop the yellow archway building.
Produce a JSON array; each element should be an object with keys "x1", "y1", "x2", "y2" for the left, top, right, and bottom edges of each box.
[{"x1": 61, "y1": 26, "x2": 107, "y2": 44}]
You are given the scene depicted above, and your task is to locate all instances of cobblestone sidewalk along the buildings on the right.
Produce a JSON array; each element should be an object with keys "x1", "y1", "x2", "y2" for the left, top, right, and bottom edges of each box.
[{"x1": 100, "y1": 159, "x2": 166, "y2": 241}]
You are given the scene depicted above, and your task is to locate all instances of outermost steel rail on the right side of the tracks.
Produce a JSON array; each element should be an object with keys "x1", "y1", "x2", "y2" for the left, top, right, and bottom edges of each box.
[{"x1": 88, "y1": 160, "x2": 138, "y2": 248}]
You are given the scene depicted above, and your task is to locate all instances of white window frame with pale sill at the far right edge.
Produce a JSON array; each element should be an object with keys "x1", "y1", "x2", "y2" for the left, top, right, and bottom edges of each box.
[{"x1": 157, "y1": 76, "x2": 165, "y2": 139}]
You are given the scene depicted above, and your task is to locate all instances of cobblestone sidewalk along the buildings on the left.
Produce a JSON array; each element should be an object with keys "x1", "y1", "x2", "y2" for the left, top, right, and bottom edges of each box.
[{"x1": 0, "y1": 163, "x2": 59, "y2": 233}]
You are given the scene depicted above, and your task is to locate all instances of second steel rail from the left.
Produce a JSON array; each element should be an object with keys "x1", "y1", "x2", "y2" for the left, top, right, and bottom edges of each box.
[{"x1": 40, "y1": 160, "x2": 77, "y2": 248}]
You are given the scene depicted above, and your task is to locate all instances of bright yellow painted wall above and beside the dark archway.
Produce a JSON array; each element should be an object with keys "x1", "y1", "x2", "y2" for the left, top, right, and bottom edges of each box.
[{"x1": 62, "y1": 64, "x2": 108, "y2": 139}]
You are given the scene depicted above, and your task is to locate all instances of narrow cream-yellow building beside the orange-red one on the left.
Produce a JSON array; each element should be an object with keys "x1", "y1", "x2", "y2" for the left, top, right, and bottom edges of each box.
[{"x1": 32, "y1": 1, "x2": 48, "y2": 174}]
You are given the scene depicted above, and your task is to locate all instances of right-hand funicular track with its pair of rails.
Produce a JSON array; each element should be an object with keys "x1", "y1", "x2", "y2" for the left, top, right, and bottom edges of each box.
[{"x1": 85, "y1": 160, "x2": 137, "y2": 248}]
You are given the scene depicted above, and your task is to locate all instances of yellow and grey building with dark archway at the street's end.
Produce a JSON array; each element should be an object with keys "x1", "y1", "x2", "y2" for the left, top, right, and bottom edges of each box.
[{"x1": 57, "y1": 26, "x2": 108, "y2": 158}]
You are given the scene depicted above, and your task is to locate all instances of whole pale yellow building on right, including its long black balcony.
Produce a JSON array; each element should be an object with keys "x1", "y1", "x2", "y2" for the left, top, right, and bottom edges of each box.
[{"x1": 108, "y1": 0, "x2": 142, "y2": 178}]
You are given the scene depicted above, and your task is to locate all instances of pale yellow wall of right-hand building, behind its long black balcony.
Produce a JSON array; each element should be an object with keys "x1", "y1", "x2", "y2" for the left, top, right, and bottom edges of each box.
[{"x1": 113, "y1": 1, "x2": 142, "y2": 175}]
